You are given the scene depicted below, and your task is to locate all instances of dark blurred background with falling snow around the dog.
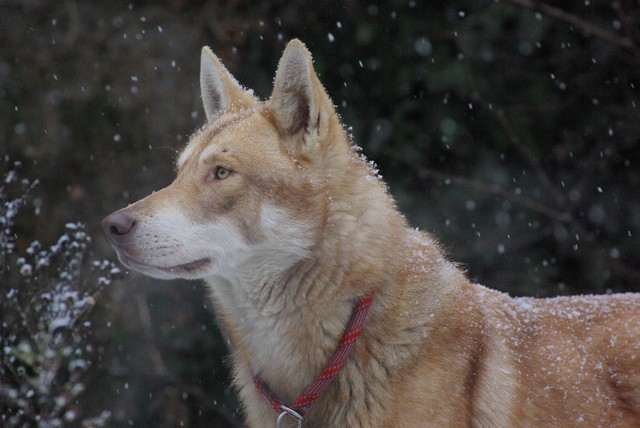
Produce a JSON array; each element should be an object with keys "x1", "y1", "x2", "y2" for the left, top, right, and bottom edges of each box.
[{"x1": 0, "y1": 0, "x2": 640, "y2": 427}]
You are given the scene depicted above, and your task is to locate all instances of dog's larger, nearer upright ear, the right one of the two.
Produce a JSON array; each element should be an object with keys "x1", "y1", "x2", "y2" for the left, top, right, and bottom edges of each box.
[{"x1": 269, "y1": 39, "x2": 334, "y2": 151}]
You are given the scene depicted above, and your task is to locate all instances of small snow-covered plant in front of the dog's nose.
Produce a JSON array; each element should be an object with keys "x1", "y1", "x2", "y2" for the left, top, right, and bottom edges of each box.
[{"x1": 0, "y1": 158, "x2": 120, "y2": 427}]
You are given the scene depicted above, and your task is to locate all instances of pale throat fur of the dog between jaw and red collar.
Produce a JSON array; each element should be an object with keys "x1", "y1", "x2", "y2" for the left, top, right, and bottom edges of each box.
[{"x1": 207, "y1": 251, "x2": 355, "y2": 402}]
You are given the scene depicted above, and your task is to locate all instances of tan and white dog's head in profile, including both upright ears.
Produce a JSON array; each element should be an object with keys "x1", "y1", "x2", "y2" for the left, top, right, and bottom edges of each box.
[{"x1": 103, "y1": 40, "x2": 354, "y2": 278}]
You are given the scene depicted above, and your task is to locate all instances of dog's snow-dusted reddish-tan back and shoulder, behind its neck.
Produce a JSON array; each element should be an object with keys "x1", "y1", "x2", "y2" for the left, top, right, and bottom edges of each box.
[{"x1": 382, "y1": 284, "x2": 640, "y2": 427}]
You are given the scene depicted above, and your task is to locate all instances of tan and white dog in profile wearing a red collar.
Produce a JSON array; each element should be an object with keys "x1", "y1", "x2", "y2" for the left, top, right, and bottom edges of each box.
[{"x1": 103, "y1": 40, "x2": 640, "y2": 427}]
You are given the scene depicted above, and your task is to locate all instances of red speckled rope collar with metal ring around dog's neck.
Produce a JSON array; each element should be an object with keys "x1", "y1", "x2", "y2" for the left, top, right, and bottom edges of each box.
[{"x1": 253, "y1": 293, "x2": 373, "y2": 426}]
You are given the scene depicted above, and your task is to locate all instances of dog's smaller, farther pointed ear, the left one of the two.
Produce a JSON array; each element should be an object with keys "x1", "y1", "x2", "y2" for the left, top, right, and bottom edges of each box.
[{"x1": 200, "y1": 46, "x2": 258, "y2": 122}]
